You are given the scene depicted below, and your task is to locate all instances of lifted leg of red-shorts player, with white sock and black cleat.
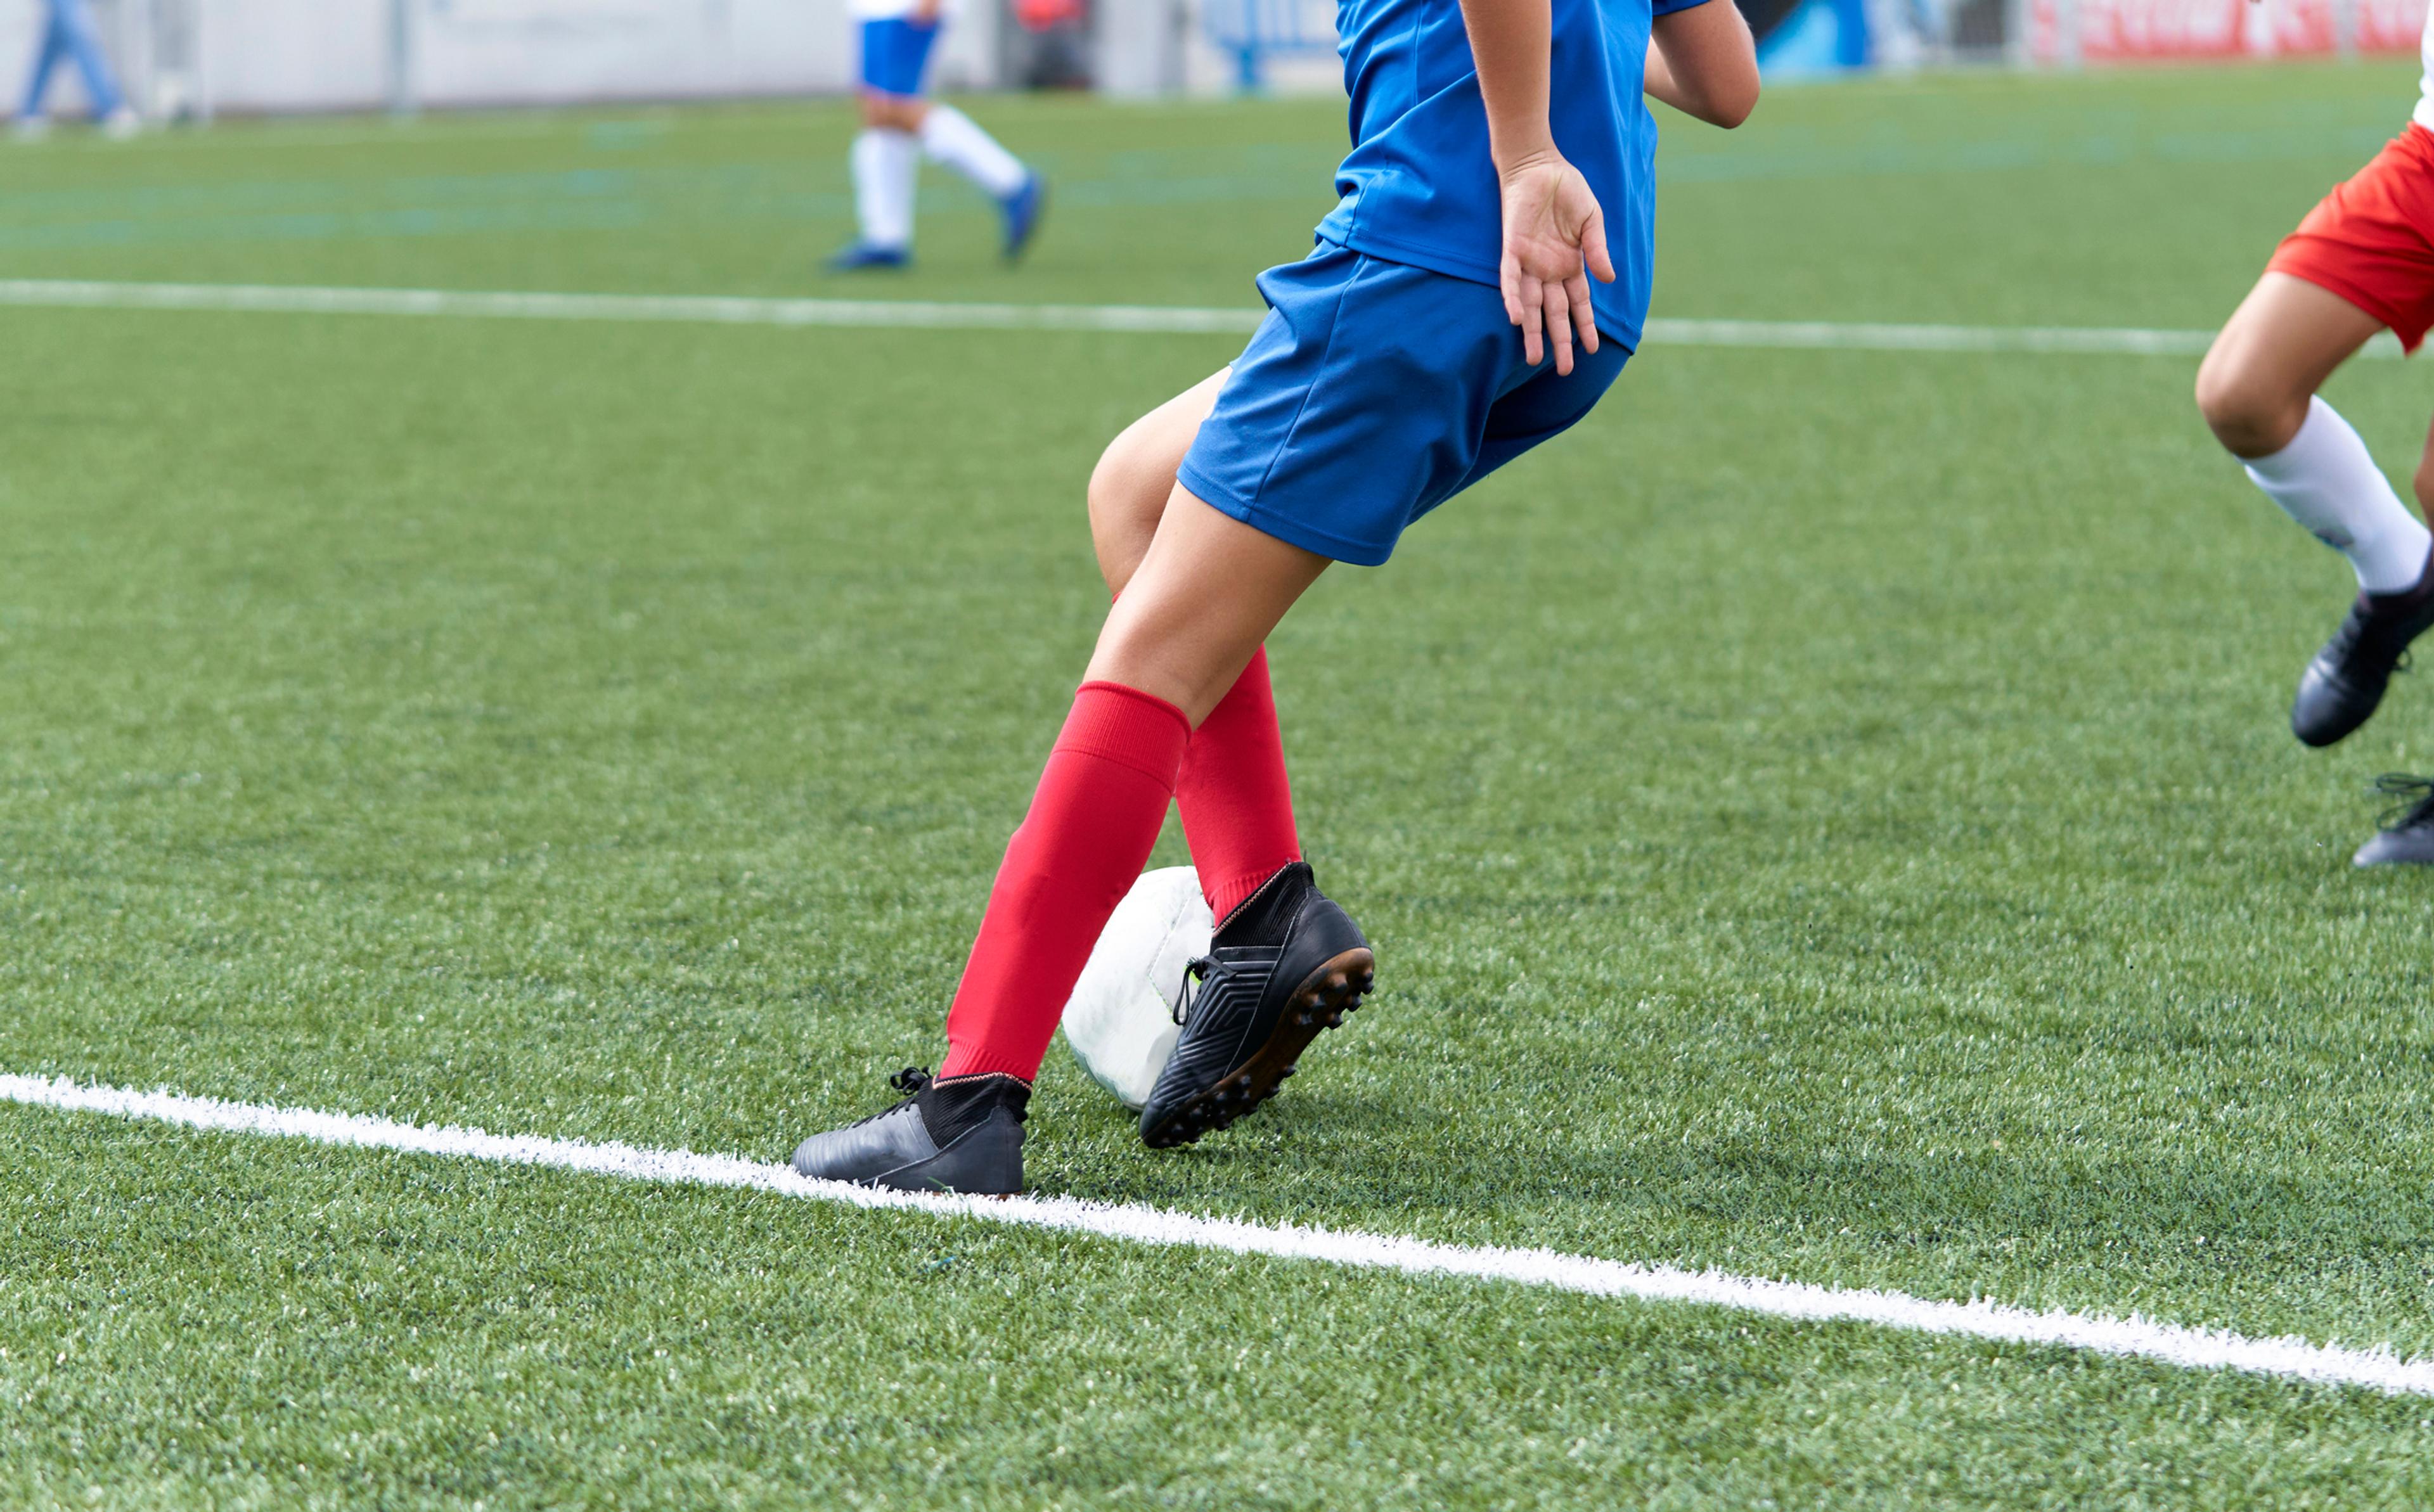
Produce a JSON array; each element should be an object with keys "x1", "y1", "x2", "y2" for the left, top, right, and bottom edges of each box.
[{"x1": 2198, "y1": 272, "x2": 2434, "y2": 745}]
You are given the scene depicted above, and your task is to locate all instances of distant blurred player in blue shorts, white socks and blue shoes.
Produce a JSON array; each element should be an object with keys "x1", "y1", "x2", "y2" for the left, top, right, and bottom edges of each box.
[{"x1": 828, "y1": 0, "x2": 1044, "y2": 272}]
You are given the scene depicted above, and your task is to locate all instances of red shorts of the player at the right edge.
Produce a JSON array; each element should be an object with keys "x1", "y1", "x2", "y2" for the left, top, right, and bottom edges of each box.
[{"x1": 2266, "y1": 124, "x2": 2434, "y2": 350}]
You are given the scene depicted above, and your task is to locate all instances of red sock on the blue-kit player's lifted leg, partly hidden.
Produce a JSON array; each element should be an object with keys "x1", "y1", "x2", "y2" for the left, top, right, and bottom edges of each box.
[{"x1": 1176, "y1": 645, "x2": 1302, "y2": 923}]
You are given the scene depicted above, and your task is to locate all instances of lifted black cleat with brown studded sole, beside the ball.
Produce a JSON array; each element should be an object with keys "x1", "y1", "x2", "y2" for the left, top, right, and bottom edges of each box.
[{"x1": 1142, "y1": 862, "x2": 1377, "y2": 1150}]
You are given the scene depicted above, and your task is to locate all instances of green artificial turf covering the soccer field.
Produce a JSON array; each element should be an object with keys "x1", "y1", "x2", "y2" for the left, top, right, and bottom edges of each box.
[{"x1": 0, "y1": 66, "x2": 2434, "y2": 1507}]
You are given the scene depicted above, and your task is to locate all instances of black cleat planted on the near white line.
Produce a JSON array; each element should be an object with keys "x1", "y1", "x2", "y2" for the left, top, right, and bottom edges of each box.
[{"x1": 794, "y1": 1067, "x2": 1032, "y2": 1198}]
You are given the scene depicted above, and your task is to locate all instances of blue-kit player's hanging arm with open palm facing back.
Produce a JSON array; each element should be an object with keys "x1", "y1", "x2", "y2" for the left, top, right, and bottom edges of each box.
[{"x1": 1463, "y1": 0, "x2": 1614, "y2": 373}]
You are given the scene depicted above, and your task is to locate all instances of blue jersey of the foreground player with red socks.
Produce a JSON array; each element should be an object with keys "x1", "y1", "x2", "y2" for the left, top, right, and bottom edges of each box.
[{"x1": 1319, "y1": 0, "x2": 1704, "y2": 346}]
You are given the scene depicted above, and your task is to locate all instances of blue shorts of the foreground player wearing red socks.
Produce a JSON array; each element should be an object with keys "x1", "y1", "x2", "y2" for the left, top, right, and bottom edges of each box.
[{"x1": 1178, "y1": 241, "x2": 1631, "y2": 567}]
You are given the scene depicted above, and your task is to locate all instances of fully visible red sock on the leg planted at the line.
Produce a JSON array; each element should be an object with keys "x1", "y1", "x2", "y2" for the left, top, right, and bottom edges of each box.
[{"x1": 937, "y1": 682, "x2": 1193, "y2": 1081}]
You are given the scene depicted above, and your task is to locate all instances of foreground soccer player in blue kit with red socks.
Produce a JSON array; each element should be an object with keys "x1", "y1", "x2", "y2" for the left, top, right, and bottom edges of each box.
[{"x1": 794, "y1": 0, "x2": 1757, "y2": 1193}]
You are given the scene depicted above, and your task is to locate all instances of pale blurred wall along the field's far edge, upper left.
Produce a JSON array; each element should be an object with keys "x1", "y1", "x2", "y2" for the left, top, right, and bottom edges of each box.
[{"x1": 0, "y1": 0, "x2": 998, "y2": 112}]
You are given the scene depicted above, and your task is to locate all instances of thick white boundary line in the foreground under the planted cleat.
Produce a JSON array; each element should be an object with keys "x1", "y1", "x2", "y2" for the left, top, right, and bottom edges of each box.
[{"x1": 0, "y1": 1073, "x2": 2434, "y2": 1395}]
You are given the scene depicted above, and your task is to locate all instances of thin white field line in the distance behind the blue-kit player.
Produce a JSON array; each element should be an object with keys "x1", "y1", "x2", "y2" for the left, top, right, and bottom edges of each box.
[{"x1": 0, "y1": 278, "x2": 2400, "y2": 358}]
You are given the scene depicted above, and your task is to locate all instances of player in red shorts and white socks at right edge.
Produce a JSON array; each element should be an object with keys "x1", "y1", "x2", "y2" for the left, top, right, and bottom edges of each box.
[{"x1": 2198, "y1": 0, "x2": 2434, "y2": 867}]
